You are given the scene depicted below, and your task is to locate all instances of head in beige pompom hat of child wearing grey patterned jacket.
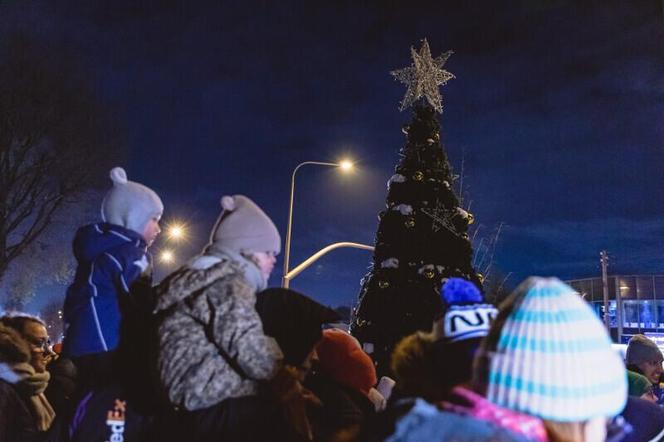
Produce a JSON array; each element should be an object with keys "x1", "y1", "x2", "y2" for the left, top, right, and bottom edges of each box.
[{"x1": 205, "y1": 195, "x2": 281, "y2": 288}]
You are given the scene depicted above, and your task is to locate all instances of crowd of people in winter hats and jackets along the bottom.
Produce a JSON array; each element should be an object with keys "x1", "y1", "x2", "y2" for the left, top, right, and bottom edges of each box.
[{"x1": 0, "y1": 168, "x2": 664, "y2": 442}]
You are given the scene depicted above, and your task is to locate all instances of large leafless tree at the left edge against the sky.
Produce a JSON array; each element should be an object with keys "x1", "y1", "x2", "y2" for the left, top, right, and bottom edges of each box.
[{"x1": 0, "y1": 34, "x2": 117, "y2": 290}]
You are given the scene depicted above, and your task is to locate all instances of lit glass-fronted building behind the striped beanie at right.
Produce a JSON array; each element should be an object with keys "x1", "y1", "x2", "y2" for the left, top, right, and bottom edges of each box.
[{"x1": 566, "y1": 275, "x2": 664, "y2": 345}]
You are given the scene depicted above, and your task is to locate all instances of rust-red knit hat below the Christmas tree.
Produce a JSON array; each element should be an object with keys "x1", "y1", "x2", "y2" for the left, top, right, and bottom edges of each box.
[{"x1": 316, "y1": 328, "x2": 377, "y2": 395}]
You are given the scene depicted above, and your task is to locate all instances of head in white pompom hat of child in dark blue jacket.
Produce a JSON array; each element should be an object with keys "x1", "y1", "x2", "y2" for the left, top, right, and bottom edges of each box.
[{"x1": 101, "y1": 167, "x2": 164, "y2": 245}]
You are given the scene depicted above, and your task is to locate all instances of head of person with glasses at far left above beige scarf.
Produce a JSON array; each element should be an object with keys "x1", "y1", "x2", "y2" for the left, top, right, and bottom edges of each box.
[{"x1": 0, "y1": 314, "x2": 54, "y2": 373}]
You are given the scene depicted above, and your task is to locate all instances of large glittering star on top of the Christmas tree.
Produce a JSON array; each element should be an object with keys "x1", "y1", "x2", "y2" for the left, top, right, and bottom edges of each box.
[{"x1": 390, "y1": 38, "x2": 455, "y2": 113}]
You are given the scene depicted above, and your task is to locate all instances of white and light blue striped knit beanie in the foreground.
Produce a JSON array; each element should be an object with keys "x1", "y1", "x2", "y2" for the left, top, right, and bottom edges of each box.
[{"x1": 475, "y1": 277, "x2": 627, "y2": 422}]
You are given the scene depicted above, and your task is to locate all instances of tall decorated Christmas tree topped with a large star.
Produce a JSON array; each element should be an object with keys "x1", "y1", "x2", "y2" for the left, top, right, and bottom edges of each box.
[{"x1": 351, "y1": 40, "x2": 481, "y2": 374}]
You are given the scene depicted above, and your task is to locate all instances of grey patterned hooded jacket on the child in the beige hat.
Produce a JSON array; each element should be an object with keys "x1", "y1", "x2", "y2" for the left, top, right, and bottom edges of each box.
[{"x1": 155, "y1": 256, "x2": 287, "y2": 410}]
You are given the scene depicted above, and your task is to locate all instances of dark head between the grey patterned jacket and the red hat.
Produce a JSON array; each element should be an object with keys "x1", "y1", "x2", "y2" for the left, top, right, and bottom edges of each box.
[{"x1": 256, "y1": 288, "x2": 339, "y2": 375}]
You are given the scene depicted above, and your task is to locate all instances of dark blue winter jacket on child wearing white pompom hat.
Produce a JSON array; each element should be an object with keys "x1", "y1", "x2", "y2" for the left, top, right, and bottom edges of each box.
[{"x1": 62, "y1": 223, "x2": 150, "y2": 357}]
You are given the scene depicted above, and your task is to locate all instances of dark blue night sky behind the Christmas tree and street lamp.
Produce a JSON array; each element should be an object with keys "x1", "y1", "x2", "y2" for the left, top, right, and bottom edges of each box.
[{"x1": 0, "y1": 0, "x2": 664, "y2": 305}]
